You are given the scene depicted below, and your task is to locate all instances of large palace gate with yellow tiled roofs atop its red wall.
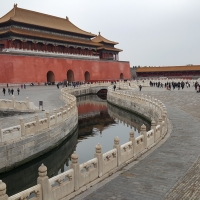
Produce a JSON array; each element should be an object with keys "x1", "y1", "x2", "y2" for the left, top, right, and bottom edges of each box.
[{"x1": 0, "y1": 4, "x2": 131, "y2": 83}]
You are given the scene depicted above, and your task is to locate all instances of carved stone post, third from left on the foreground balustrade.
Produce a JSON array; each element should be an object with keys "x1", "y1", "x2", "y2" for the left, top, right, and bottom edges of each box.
[{"x1": 70, "y1": 152, "x2": 80, "y2": 191}]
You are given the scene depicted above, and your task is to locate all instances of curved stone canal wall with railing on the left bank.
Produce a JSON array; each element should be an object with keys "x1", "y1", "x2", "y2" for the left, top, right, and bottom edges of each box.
[{"x1": 0, "y1": 92, "x2": 78, "y2": 173}]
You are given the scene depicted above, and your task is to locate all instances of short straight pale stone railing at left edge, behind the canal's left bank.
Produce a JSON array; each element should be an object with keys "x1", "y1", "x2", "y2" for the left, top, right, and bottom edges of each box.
[{"x1": 0, "y1": 95, "x2": 38, "y2": 111}]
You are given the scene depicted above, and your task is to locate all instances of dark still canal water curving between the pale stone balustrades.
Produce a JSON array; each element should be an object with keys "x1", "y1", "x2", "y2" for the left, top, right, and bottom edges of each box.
[{"x1": 0, "y1": 95, "x2": 150, "y2": 196}]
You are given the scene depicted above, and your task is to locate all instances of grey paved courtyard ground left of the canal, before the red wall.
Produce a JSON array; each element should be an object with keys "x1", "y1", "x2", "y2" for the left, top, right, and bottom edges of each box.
[{"x1": 0, "y1": 86, "x2": 65, "y2": 128}]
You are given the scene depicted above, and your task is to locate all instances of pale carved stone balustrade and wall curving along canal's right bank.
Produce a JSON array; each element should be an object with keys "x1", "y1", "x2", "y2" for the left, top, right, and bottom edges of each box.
[{"x1": 0, "y1": 87, "x2": 167, "y2": 200}]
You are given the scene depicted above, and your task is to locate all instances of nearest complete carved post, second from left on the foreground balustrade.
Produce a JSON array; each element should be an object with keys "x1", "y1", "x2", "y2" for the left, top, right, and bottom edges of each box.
[{"x1": 37, "y1": 164, "x2": 53, "y2": 200}]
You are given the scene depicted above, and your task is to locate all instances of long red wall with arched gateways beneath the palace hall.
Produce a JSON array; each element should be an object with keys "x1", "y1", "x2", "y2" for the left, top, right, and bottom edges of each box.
[{"x1": 0, "y1": 54, "x2": 131, "y2": 83}]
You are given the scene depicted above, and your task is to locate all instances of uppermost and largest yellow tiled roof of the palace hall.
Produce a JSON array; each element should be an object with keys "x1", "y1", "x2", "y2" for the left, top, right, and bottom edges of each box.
[{"x1": 0, "y1": 5, "x2": 96, "y2": 37}]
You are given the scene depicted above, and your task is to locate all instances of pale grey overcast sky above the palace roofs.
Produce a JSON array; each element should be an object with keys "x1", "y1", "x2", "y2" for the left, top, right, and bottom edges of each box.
[{"x1": 0, "y1": 0, "x2": 200, "y2": 66}]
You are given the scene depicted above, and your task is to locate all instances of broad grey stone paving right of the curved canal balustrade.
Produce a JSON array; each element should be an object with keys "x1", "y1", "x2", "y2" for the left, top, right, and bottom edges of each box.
[{"x1": 78, "y1": 88, "x2": 200, "y2": 200}]
